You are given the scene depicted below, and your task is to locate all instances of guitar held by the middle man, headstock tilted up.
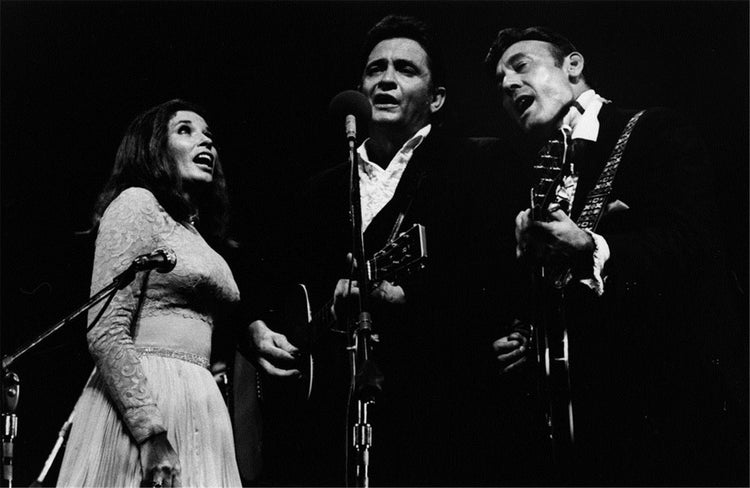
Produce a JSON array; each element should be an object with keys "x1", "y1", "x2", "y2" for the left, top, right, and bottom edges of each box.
[{"x1": 261, "y1": 224, "x2": 427, "y2": 404}]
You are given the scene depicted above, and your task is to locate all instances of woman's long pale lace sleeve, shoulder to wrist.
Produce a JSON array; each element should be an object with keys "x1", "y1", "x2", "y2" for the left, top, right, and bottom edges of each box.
[{"x1": 87, "y1": 188, "x2": 170, "y2": 443}]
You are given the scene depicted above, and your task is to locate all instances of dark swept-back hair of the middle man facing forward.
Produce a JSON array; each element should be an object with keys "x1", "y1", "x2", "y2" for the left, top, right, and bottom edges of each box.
[{"x1": 361, "y1": 15, "x2": 445, "y2": 87}]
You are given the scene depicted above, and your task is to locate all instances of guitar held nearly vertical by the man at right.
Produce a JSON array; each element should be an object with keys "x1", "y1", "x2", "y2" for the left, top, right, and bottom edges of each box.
[{"x1": 531, "y1": 128, "x2": 575, "y2": 463}]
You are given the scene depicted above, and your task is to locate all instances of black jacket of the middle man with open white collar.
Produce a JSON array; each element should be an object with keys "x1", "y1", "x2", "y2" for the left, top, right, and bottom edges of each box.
[{"x1": 262, "y1": 127, "x2": 524, "y2": 486}]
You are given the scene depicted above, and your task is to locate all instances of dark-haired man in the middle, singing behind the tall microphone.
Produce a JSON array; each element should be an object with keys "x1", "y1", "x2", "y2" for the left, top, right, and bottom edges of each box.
[{"x1": 252, "y1": 16, "x2": 513, "y2": 486}]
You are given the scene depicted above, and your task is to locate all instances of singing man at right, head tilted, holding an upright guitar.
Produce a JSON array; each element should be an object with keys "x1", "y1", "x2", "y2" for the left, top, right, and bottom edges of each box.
[{"x1": 485, "y1": 27, "x2": 747, "y2": 486}]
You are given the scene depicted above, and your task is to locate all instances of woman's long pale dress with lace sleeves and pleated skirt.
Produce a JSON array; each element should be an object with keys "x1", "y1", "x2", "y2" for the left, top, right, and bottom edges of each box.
[{"x1": 58, "y1": 187, "x2": 240, "y2": 487}]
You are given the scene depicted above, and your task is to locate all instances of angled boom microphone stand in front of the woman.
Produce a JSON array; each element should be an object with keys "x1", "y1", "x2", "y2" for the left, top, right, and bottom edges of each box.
[{"x1": 2, "y1": 262, "x2": 144, "y2": 487}]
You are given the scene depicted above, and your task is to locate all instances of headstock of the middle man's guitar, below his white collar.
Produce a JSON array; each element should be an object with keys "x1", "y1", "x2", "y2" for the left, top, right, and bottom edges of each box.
[{"x1": 367, "y1": 224, "x2": 427, "y2": 283}]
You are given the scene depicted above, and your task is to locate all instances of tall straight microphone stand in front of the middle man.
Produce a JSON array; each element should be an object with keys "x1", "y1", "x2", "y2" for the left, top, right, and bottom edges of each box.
[{"x1": 347, "y1": 127, "x2": 383, "y2": 488}]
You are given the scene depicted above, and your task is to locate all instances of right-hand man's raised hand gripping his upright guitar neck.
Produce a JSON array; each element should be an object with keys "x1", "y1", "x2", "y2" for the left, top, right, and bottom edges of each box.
[{"x1": 516, "y1": 208, "x2": 595, "y2": 265}]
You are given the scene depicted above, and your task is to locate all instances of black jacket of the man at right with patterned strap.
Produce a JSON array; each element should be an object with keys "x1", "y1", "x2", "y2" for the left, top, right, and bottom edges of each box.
[{"x1": 544, "y1": 105, "x2": 747, "y2": 484}]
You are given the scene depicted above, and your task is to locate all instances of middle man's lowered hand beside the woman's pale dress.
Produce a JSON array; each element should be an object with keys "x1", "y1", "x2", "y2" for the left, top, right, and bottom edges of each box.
[{"x1": 248, "y1": 320, "x2": 300, "y2": 376}]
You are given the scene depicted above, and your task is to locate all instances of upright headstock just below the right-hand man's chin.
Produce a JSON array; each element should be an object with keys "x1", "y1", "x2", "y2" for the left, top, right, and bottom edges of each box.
[{"x1": 531, "y1": 127, "x2": 570, "y2": 220}]
